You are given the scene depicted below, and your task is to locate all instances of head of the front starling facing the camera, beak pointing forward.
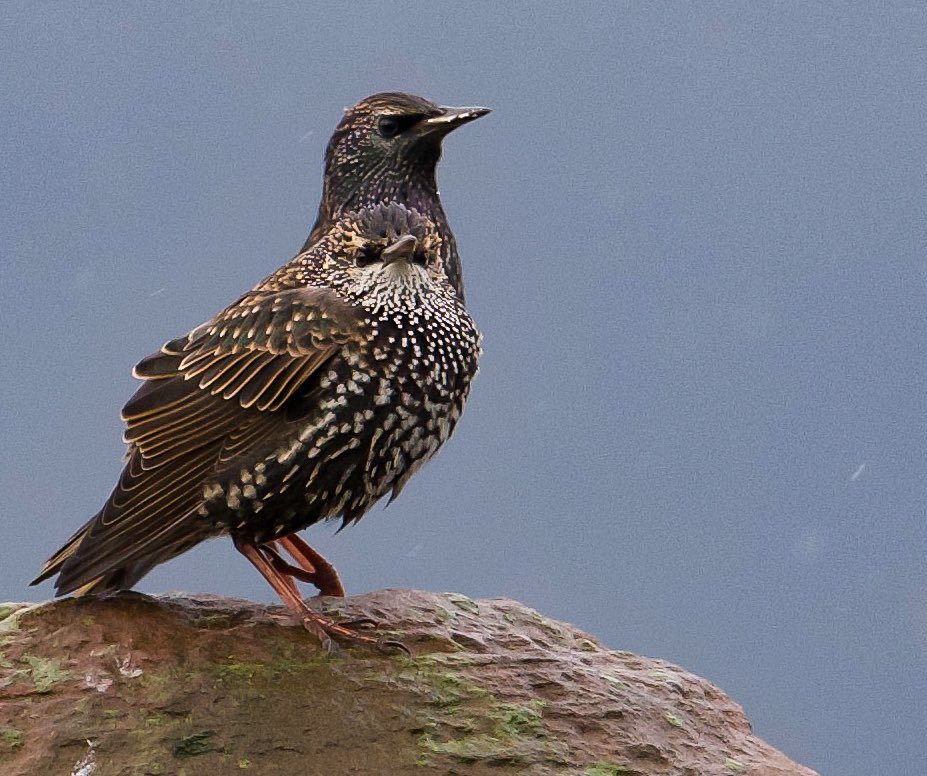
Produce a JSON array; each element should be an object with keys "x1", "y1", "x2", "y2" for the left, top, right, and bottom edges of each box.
[{"x1": 307, "y1": 202, "x2": 454, "y2": 307}]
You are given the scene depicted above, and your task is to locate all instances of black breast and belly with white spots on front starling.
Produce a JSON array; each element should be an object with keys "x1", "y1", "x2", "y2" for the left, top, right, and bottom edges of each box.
[{"x1": 214, "y1": 300, "x2": 479, "y2": 540}]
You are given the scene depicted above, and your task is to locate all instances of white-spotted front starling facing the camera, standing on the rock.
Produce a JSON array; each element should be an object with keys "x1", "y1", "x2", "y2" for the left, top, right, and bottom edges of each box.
[{"x1": 33, "y1": 203, "x2": 481, "y2": 646}]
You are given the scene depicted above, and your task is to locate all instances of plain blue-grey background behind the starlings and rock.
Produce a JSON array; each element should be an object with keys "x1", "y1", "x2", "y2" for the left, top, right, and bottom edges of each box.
[{"x1": 0, "y1": 2, "x2": 927, "y2": 776}]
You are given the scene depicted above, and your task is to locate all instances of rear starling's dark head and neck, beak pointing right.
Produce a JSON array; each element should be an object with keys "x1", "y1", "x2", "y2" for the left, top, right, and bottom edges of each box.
[{"x1": 303, "y1": 92, "x2": 489, "y2": 299}]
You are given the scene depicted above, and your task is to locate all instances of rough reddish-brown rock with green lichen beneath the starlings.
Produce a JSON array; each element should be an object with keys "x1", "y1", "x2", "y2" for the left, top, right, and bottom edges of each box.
[{"x1": 0, "y1": 590, "x2": 813, "y2": 776}]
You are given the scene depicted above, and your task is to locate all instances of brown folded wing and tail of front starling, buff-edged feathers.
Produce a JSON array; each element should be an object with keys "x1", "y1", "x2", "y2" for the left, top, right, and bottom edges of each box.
[{"x1": 39, "y1": 288, "x2": 362, "y2": 592}]
